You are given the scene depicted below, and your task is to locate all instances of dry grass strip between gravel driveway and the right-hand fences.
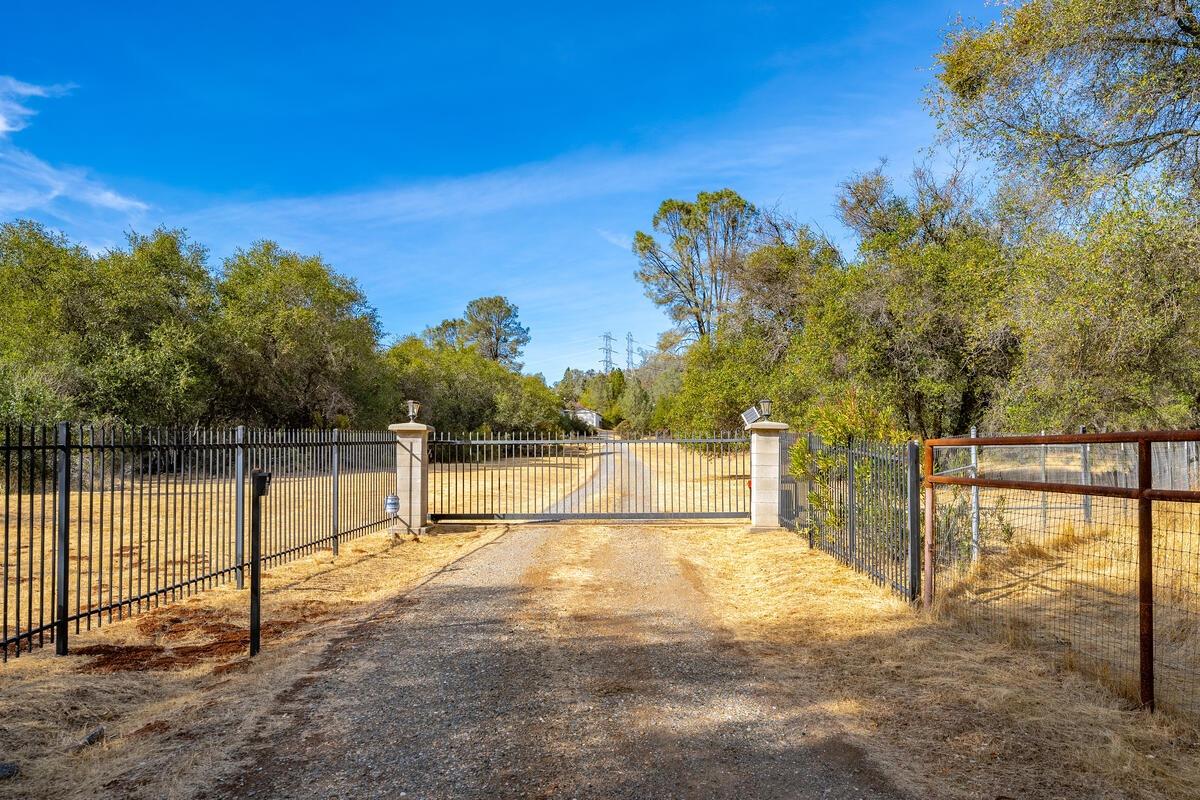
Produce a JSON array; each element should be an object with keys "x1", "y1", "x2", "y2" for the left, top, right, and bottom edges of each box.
[{"x1": 665, "y1": 529, "x2": 1200, "y2": 799}]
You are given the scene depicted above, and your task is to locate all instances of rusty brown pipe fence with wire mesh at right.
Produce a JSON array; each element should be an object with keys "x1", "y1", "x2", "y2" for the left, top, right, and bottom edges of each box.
[{"x1": 923, "y1": 431, "x2": 1200, "y2": 715}]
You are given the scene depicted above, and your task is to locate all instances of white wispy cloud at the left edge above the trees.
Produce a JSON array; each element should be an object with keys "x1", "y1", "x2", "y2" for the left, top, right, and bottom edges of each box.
[{"x1": 0, "y1": 76, "x2": 149, "y2": 222}]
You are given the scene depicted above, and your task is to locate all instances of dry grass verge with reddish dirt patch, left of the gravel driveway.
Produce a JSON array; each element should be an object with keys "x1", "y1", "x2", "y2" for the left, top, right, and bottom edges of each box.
[{"x1": 0, "y1": 527, "x2": 504, "y2": 799}]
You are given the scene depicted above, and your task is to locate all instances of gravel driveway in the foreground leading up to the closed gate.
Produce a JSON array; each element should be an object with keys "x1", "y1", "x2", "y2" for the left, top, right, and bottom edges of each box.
[{"x1": 214, "y1": 525, "x2": 902, "y2": 799}]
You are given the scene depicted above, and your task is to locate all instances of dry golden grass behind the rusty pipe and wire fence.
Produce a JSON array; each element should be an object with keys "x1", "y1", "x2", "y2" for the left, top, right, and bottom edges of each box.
[{"x1": 938, "y1": 492, "x2": 1200, "y2": 718}]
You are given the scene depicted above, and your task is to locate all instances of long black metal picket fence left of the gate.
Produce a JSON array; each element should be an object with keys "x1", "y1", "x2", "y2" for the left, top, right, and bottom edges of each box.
[{"x1": 0, "y1": 423, "x2": 396, "y2": 661}]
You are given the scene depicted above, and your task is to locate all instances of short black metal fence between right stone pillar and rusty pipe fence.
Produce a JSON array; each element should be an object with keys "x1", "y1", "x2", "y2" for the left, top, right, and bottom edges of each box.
[{"x1": 780, "y1": 433, "x2": 922, "y2": 600}]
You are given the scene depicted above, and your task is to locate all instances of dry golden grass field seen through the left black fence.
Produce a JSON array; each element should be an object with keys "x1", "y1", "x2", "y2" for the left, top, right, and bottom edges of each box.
[{"x1": 0, "y1": 470, "x2": 395, "y2": 656}]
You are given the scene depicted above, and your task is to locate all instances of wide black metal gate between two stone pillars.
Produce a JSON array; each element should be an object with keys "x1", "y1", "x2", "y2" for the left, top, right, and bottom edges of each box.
[{"x1": 430, "y1": 433, "x2": 750, "y2": 519}]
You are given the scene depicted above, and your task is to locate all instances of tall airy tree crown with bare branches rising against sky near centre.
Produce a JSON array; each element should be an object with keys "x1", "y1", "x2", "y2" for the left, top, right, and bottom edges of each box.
[{"x1": 634, "y1": 188, "x2": 757, "y2": 339}]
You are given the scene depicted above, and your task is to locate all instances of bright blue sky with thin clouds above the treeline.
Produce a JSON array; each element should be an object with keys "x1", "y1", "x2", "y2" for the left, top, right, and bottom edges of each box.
[{"x1": 0, "y1": 0, "x2": 994, "y2": 381}]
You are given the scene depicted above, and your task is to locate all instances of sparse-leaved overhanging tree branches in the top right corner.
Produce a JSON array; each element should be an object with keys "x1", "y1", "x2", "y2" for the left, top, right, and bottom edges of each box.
[{"x1": 932, "y1": 0, "x2": 1200, "y2": 192}]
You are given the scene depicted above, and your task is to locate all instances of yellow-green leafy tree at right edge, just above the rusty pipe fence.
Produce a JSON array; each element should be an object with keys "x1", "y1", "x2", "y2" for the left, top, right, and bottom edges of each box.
[{"x1": 989, "y1": 191, "x2": 1200, "y2": 432}]
